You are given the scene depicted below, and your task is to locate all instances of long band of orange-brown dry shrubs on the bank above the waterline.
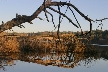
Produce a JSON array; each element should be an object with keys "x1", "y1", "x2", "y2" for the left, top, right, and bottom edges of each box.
[{"x1": 0, "y1": 36, "x2": 85, "y2": 52}]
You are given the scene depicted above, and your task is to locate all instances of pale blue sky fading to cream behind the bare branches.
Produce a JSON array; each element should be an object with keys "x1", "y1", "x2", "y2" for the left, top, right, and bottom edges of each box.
[{"x1": 0, "y1": 0, "x2": 108, "y2": 32}]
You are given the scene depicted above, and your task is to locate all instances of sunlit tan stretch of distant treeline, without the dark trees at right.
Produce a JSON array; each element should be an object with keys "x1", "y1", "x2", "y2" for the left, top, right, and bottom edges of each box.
[{"x1": 0, "y1": 31, "x2": 73, "y2": 36}]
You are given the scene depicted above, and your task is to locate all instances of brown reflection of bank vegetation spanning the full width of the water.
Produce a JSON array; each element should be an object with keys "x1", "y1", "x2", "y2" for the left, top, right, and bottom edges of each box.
[{"x1": 0, "y1": 46, "x2": 108, "y2": 70}]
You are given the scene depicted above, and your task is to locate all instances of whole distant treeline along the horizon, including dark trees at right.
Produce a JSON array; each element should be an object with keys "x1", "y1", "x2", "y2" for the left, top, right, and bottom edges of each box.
[{"x1": 0, "y1": 30, "x2": 108, "y2": 39}]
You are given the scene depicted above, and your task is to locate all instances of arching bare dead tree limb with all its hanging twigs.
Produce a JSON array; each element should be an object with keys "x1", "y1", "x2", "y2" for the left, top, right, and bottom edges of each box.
[{"x1": 0, "y1": 0, "x2": 108, "y2": 35}]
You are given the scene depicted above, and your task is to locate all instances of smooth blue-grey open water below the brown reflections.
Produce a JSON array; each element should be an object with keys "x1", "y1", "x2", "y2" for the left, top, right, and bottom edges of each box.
[{"x1": 1, "y1": 59, "x2": 108, "y2": 72}]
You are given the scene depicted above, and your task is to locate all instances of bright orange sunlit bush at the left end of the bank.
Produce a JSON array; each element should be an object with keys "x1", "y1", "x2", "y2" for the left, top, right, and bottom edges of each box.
[{"x1": 0, "y1": 37, "x2": 19, "y2": 52}]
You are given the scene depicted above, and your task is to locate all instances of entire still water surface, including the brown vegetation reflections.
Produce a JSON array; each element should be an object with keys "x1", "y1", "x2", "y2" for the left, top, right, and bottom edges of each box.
[{"x1": 0, "y1": 46, "x2": 108, "y2": 72}]
